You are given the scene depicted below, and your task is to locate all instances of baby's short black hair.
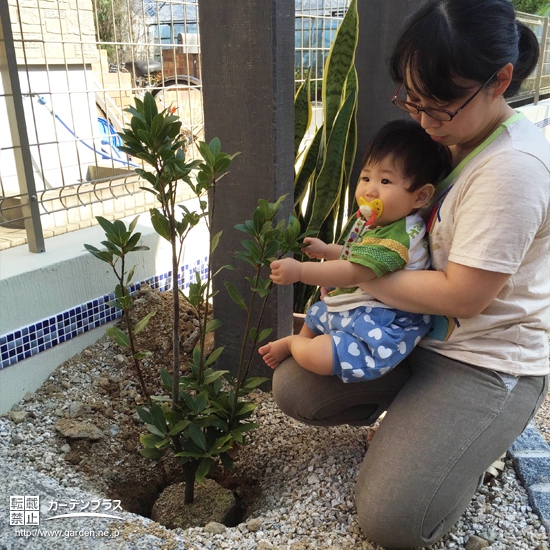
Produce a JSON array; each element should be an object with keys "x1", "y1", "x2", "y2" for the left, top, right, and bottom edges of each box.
[{"x1": 362, "y1": 120, "x2": 451, "y2": 193}]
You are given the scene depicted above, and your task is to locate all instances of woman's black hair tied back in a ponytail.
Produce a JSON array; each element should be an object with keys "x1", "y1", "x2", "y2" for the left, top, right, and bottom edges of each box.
[{"x1": 390, "y1": 0, "x2": 539, "y2": 101}]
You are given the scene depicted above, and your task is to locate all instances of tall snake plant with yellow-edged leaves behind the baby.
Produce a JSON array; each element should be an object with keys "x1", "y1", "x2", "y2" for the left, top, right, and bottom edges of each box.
[{"x1": 294, "y1": 0, "x2": 359, "y2": 312}]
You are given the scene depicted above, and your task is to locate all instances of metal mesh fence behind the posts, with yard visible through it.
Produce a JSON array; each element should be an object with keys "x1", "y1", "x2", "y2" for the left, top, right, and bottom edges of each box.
[{"x1": 0, "y1": 0, "x2": 550, "y2": 252}]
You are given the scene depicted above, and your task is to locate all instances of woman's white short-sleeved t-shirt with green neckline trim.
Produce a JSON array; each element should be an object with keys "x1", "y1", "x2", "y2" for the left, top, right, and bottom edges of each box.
[{"x1": 420, "y1": 114, "x2": 550, "y2": 376}]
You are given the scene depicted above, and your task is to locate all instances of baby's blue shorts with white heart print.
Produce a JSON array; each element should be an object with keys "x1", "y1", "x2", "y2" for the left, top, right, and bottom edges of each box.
[{"x1": 306, "y1": 302, "x2": 432, "y2": 382}]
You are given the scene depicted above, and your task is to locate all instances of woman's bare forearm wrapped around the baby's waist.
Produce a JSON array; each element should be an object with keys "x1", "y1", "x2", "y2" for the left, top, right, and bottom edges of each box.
[{"x1": 359, "y1": 262, "x2": 510, "y2": 319}]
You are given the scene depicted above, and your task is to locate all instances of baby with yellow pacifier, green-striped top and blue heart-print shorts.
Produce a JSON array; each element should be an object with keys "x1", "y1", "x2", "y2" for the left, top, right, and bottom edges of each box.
[{"x1": 259, "y1": 120, "x2": 451, "y2": 382}]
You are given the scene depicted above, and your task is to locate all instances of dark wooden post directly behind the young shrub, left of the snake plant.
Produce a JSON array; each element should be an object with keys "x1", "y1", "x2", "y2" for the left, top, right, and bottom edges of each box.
[{"x1": 199, "y1": 0, "x2": 295, "y2": 376}]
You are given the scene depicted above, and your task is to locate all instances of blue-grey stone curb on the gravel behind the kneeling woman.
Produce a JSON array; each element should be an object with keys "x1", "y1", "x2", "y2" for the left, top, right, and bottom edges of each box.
[{"x1": 508, "y1": 421, "x2": 550, "y2": 533}]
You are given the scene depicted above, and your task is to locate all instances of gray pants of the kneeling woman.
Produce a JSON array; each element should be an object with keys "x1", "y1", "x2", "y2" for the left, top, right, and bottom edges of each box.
[{"x1": 273, "y1": 348, "x2": 548, "y2": 548}]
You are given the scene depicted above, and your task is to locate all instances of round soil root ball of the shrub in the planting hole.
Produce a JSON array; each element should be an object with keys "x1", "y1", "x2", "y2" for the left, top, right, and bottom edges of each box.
[{"x1": 151, "y1": 479, "x2": 237, "y2": 529}]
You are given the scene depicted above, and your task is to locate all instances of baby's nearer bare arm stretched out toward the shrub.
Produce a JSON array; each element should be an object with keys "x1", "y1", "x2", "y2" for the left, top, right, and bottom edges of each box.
[{"x1": 270, "y1": 258, "x2": 376, "y2": 287}]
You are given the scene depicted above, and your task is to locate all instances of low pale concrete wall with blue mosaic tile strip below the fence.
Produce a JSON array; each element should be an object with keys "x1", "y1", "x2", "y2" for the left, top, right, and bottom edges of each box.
[{"x1": 0, "y1": 201, "x2": 207, "y2": 414}]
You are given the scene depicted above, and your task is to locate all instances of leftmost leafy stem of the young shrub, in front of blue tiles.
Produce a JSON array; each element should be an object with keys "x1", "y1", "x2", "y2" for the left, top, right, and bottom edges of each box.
[{"x1": 84, "y1": 216, "x2": 156, "y2": 402}]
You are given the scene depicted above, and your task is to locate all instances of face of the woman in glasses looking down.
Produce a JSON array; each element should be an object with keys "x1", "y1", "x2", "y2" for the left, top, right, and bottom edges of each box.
[{"x1": 405, "y1": 76, "x2": 504, "y2": 149}]
